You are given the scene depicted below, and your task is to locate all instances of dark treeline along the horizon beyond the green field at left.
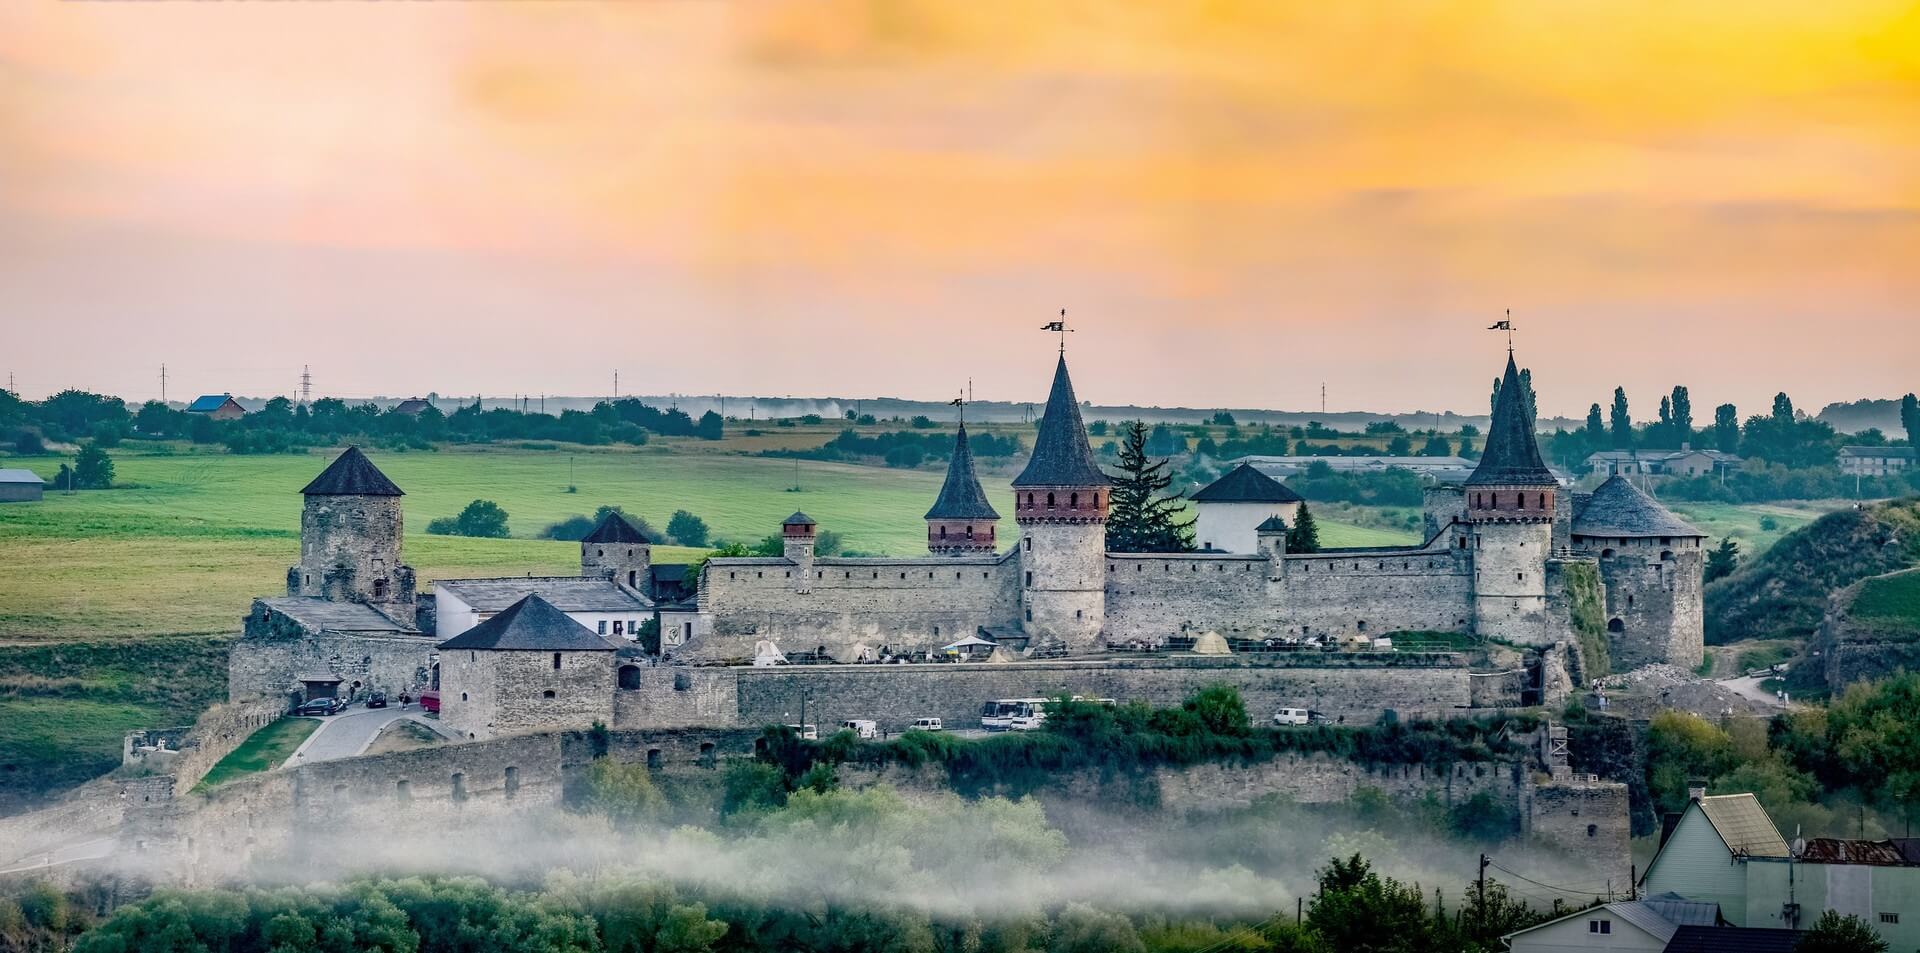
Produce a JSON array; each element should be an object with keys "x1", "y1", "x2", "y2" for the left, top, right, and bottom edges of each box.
[{"x1": 0, "y1": 390, "x2": 726, "y2": 453}]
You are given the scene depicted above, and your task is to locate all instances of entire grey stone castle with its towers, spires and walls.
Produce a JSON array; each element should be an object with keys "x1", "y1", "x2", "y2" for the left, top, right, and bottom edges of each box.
[{"x1": 228, "y1": 345, "x2": 1705, "y2": 738}]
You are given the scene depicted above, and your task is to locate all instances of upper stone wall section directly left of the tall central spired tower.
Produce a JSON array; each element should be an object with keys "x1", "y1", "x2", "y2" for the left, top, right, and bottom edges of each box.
[{"x1": 676, "y1": 551, "x2": 1020, "y2": 659}]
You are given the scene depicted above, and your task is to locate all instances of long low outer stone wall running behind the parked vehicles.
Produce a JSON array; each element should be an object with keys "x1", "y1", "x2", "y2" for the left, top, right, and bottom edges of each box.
[{"x1": 614, "y1": 651, "x2": 1473, "y2": 732}]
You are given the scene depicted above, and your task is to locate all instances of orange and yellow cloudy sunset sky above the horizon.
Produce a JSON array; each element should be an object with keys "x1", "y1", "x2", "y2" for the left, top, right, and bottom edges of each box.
[{"x1": 0, "y1": 0, "x2": 1920, "y2": 417}]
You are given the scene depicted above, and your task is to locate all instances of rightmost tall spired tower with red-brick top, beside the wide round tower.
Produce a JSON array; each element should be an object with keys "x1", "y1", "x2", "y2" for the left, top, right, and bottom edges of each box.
[{"x1": 1465, "y1": 352, "x2": 1559, "y2": 644}]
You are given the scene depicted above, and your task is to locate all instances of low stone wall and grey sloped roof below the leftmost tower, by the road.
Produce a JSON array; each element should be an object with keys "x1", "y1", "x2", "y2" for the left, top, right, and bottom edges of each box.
[{"x1": 227, "y1": 601, "x2": 438, "y2": 701}]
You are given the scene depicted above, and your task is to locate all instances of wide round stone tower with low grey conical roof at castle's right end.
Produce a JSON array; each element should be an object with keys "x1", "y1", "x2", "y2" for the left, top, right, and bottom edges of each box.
[{"x1": 1571, "y1": 475, "x2": 1707, "y2": 671}]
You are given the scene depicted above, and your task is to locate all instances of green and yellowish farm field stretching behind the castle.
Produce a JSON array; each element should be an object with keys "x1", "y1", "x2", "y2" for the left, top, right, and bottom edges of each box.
[{"x1": 0, "y1": 446, "x2": 1413, "y2": 642}]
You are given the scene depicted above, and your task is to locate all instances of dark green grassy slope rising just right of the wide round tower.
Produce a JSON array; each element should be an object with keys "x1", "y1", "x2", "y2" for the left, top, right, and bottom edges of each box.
[{"x1": 1705, "y1": 500, "x2": 1920, "y2": 646}]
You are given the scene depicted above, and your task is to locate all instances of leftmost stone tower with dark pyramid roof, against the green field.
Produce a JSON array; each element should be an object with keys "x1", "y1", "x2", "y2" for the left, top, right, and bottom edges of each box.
[{"x1": 286, "y1": 446, "x2": 413, "y2": 610}]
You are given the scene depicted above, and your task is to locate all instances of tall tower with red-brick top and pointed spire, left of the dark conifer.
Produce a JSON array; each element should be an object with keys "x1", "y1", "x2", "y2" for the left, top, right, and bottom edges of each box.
[{"x1": 1014, "y1": 355, "x2": 1112, "y2": 653}]
